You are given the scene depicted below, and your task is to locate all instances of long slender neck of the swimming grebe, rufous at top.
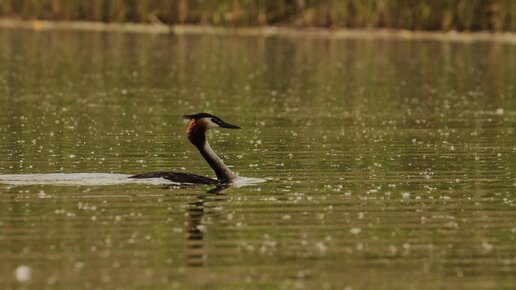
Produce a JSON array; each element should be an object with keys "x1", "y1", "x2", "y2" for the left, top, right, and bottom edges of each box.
[{"x1": 187, "y1": 120, "x2": 236, "y2": 182}]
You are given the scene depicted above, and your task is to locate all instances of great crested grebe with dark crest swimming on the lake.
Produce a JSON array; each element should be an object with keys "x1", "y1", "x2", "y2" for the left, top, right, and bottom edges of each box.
[{"x1": 129, "y1": 113, "x2": 241, "y2": 184}]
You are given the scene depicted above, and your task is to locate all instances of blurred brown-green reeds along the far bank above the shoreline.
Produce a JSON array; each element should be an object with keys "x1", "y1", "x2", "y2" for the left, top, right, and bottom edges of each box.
[{"x1": 0, "y1": 0, "x2": 516, "y2": 31}]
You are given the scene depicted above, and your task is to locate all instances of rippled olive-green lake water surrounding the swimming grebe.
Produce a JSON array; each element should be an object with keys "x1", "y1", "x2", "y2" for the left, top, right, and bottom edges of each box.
[{"x1": 0, "y1": 29, "x2": 516, "y2": 290}]
